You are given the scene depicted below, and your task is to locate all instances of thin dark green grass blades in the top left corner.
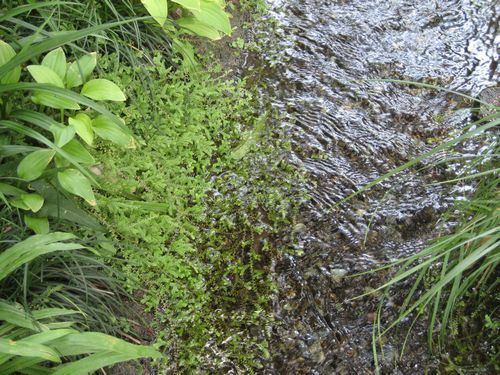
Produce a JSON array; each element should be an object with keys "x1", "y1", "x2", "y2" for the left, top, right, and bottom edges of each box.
[{"x1": 0, "y1": 0, "x2": 171, "y2": 61}]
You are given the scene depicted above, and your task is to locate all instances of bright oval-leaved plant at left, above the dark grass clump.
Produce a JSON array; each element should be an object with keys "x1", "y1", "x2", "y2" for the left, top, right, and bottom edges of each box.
[{"x1": 0, "y1": 43, "x2": 132, "y2": 220}]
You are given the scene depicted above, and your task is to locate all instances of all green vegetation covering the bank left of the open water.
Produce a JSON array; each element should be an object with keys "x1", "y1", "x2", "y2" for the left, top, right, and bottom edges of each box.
[{"x1": 0, "y1": 0, "x2": 300, "y2": 374}]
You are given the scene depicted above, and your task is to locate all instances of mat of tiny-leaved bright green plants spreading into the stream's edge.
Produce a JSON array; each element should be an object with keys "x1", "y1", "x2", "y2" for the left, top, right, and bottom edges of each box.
[{"x1": 95, "y1": 53, "x2": 298, "y2": 373}]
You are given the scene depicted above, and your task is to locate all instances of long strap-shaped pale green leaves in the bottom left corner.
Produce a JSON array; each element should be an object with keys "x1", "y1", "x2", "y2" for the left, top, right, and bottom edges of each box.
[{"x1": 0, "y1": 232, "x2": 161, "y2": 375}]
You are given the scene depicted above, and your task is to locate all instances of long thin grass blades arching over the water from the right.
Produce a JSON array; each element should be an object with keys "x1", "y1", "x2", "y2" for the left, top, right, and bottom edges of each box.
[{"x1": 349, "y1": 81, "x2": 500, "y2": 371}]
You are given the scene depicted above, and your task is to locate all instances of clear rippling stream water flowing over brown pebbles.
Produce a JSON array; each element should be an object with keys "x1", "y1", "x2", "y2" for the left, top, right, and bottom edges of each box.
[{"x1": 252, "y1": 0, "x2": 500, "y2": 374}]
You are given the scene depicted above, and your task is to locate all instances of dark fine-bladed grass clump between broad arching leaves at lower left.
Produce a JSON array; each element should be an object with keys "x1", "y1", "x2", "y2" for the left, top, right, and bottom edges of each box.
[{"x1": 0, "y1": 209, "x2": 132, "y2": 334}]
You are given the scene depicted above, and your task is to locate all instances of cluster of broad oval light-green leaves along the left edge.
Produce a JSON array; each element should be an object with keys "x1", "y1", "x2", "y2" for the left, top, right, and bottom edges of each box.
[{"x1": 0, "y1": 41, "x2": 133, "y2": 233}]
